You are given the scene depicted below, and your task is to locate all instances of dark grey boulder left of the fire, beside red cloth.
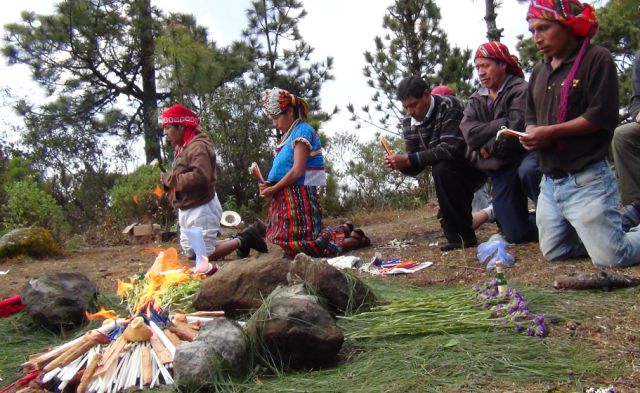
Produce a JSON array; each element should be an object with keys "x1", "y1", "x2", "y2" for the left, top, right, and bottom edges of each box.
[{"x1": 20, "y1": 272, "x2": 98, "y2": 330}]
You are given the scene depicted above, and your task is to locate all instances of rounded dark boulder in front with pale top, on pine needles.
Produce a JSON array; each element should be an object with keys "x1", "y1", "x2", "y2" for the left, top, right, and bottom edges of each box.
[{"x1": 247, "y1": 288, "x2": 344, "y2": 369}]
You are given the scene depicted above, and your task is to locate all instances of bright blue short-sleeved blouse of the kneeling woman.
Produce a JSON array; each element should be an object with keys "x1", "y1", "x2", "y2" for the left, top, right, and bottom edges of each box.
[{"x1": 267, "y1": 121, "x2": 327, "y2": 186}]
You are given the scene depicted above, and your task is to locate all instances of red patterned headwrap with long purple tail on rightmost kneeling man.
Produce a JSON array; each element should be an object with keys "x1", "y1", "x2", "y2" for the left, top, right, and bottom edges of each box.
[{"x1": 527, "y1": 0, "x2": 598, "y2": 123}]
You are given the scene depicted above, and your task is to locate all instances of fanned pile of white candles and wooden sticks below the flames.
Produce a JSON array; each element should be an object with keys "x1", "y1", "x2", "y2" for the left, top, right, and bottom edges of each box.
[{"x1": 15, "y1": 307, "x2": 224, "y2": 393}]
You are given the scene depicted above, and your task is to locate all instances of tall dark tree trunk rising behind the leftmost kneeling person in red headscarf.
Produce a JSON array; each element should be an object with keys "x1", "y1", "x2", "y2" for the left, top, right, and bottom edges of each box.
[{"x1": 135, "y1": 0, "x2": 162, "y2": 163}]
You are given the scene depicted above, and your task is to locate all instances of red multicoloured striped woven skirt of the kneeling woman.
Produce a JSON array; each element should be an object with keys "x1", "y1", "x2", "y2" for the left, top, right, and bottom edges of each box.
[{"x1": 266, "y1": 185, "x2": 342, "y2": 258}]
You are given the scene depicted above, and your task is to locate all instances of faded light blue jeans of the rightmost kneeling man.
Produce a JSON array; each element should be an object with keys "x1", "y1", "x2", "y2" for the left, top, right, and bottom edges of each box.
[{"x1": 536, "y1": 161, "x2": 640, "y2": 267}]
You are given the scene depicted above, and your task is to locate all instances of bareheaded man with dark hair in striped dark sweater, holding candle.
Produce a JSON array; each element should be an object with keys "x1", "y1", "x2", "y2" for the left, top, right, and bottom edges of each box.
[{"x1": 384, "y1": 76, "x2": 485, "y2": 251}]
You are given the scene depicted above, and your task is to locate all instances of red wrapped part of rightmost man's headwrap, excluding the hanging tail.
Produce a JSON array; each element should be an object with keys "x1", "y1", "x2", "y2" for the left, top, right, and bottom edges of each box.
[{"x1": 527, "y1": 0, "x2": 598, "y2": 37}]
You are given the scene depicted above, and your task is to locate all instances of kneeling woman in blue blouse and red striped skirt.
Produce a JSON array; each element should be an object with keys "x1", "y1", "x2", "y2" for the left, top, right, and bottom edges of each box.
[{"x1": 260, "y1": 87, "x2": 370, "y2": 258}]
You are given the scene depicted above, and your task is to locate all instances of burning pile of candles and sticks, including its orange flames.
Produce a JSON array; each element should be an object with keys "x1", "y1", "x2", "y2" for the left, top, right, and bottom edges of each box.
[{"x1": 5, "y1": 248, "x2": 224, "y2": 393}]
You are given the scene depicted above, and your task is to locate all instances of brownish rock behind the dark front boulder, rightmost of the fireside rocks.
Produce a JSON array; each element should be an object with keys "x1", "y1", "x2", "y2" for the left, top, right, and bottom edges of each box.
[{"x1": 289, "y1": 254, "x2": 376, "y2": 315}]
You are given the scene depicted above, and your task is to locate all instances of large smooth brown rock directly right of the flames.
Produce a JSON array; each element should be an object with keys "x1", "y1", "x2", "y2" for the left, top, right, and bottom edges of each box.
[{"x1": 193, "y1": 256, "x2": 290, "y2": 318}]
